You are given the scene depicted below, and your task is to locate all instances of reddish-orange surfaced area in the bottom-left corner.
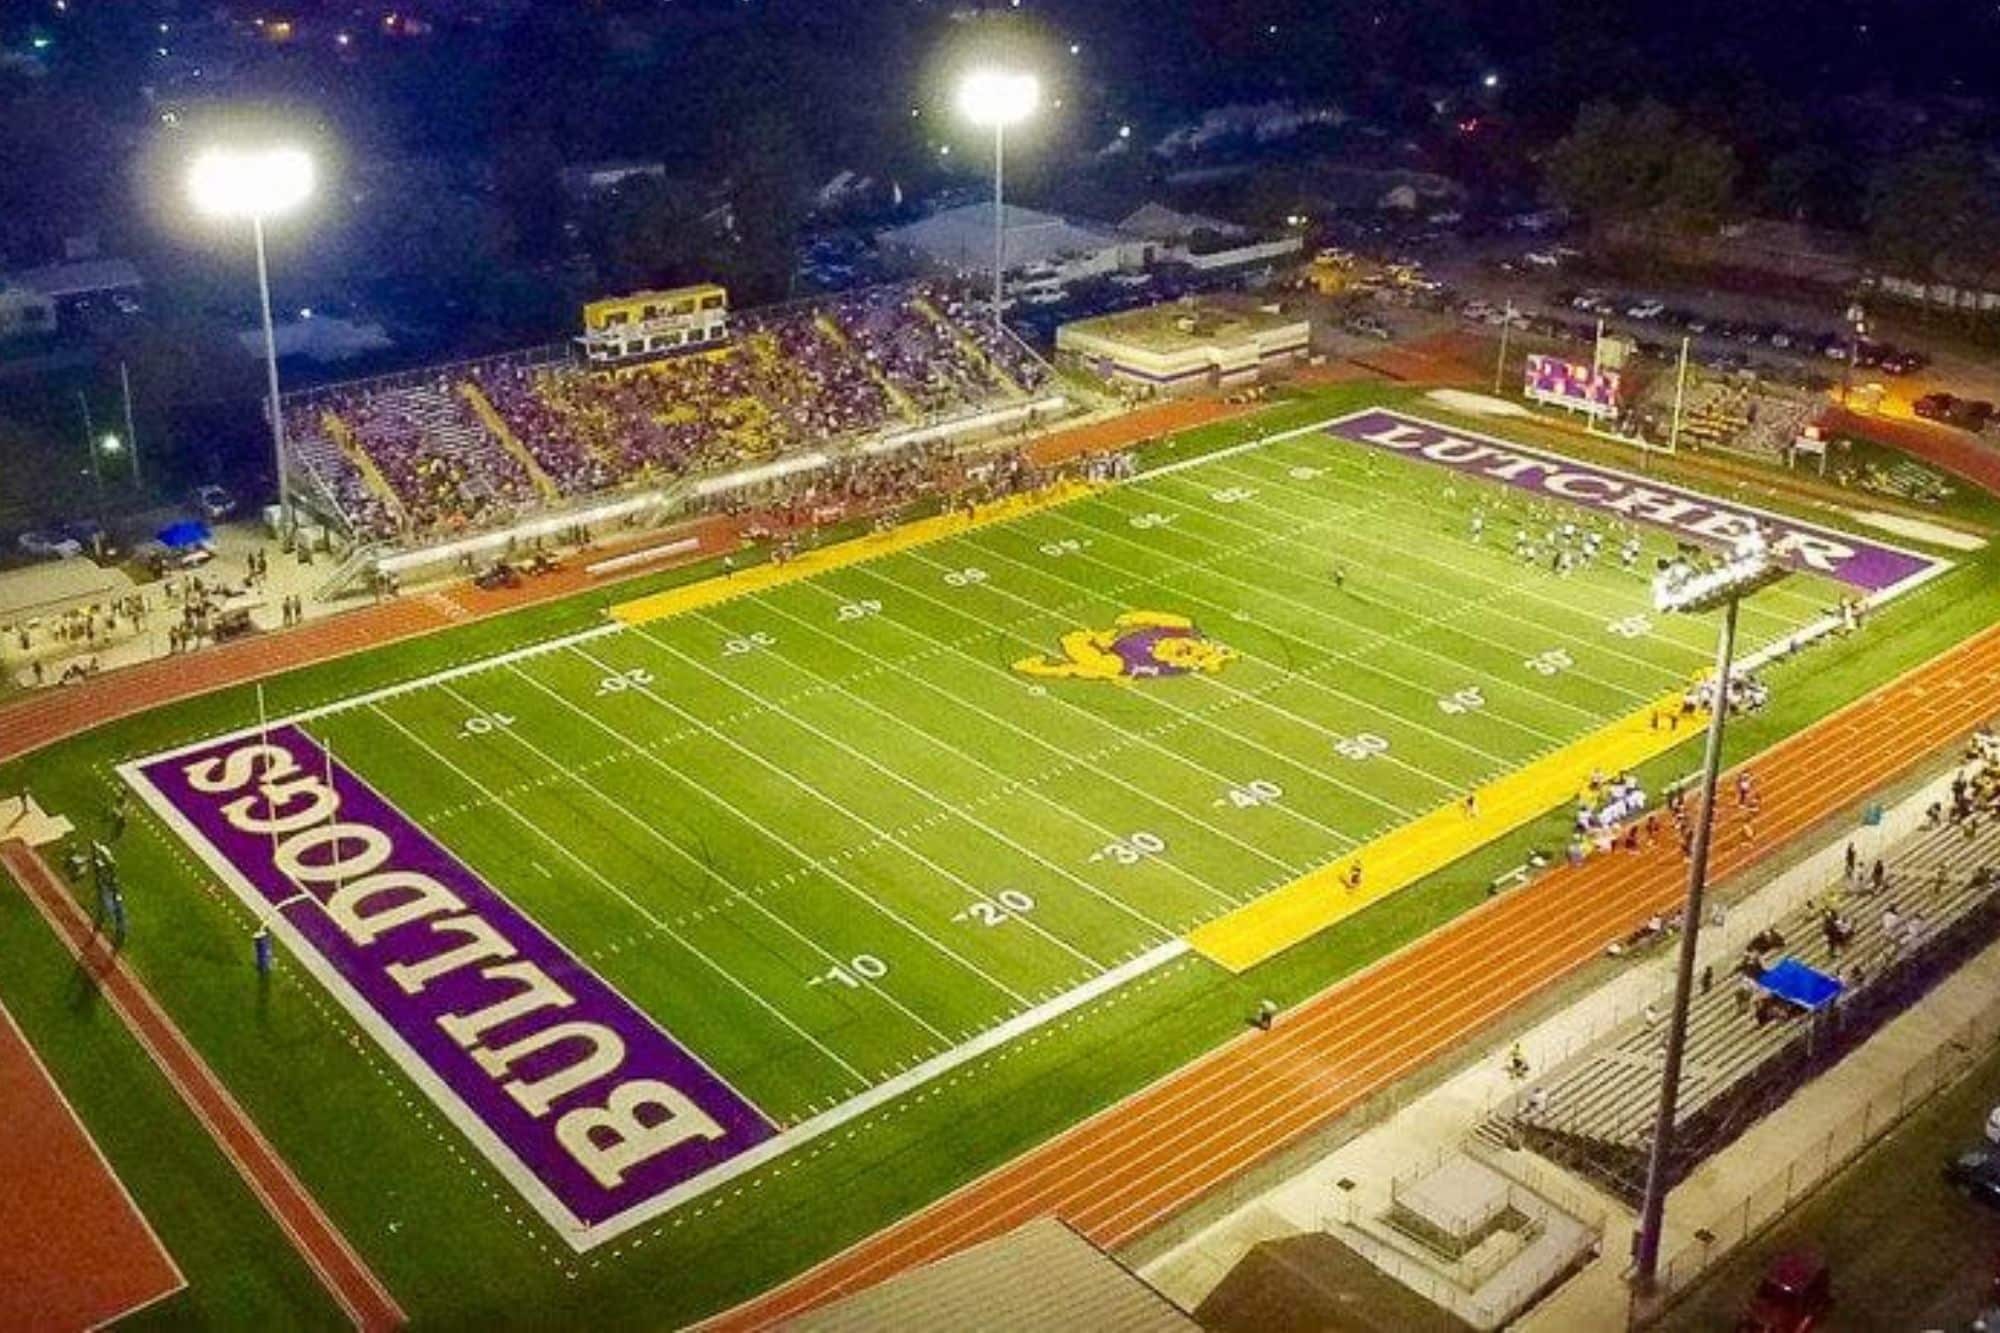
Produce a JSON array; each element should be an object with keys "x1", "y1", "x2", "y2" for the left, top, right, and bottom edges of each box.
[{"x1": 0, "y1": 992, "x2": 186, "y2": 1333}]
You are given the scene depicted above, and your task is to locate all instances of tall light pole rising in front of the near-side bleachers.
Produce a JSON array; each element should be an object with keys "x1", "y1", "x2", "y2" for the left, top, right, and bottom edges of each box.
[{"x1": 1632, "y1": 534, "x2": 1786, "y2": 1295}]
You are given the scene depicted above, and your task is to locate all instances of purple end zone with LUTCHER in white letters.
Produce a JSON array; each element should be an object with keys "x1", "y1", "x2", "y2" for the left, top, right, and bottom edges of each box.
[{"x1": 1326, "y1": 410, "x2": 1942, "y2": 592}]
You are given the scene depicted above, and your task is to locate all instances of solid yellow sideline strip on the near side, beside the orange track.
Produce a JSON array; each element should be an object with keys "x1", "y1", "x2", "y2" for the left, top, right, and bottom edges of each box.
[{"x1": 1188, "y1": 695, "x2": 1706, "y2": 973}]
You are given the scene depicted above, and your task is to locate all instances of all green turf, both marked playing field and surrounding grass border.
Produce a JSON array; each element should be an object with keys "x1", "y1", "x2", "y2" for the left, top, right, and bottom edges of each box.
[{"x1": 0, "y1": 378, "x2": 1992, "y2": 1325}]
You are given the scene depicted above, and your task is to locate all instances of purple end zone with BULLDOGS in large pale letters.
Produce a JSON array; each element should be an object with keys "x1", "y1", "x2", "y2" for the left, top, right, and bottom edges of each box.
[{"x1": 136, "y1": 727, "x2": 776, "y2": 1227}]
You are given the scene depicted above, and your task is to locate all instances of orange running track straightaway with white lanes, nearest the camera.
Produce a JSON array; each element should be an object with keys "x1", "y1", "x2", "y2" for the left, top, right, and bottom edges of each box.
[{"x1": 708, "y1": 626, "x2": 2000, "y2": 1329}]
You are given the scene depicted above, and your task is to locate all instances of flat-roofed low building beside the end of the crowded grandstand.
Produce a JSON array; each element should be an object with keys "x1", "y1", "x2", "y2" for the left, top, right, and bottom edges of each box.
[{"x1": 1056, "y1": 296, "x2": 1312, "y2": 394}]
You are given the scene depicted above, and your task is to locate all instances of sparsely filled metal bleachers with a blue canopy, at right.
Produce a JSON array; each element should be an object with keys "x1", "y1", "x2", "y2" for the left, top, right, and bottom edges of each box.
[{"x1": 1478, "y1": 792, "x2": 2000, "y2": 1199}]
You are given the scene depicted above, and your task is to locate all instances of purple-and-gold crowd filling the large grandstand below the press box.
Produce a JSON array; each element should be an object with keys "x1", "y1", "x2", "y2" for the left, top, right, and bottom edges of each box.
[{"x1": 286, "y1": 284, "x2": 1050, "y2": 540}]
